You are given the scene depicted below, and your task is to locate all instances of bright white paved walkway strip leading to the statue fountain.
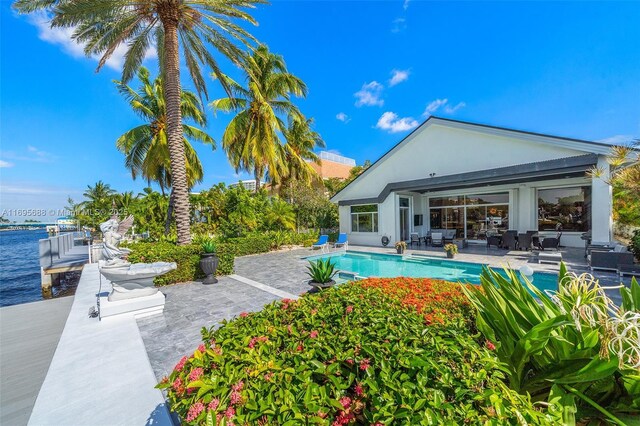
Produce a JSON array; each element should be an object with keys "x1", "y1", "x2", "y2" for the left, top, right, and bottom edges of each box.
[{"x1": 26, "y1": 263, "x2": 171, "y2": 426}]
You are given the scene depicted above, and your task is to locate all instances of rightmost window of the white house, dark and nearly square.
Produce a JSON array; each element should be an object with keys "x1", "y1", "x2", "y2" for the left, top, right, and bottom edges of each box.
[{"x1": 538, "y1": 186, "x2": 591, "y2": 232}]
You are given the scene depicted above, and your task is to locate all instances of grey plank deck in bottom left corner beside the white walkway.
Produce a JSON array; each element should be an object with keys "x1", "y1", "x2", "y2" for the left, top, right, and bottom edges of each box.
[{"x1": 0, "y1": 296, "x2": 73, "y2": 426}]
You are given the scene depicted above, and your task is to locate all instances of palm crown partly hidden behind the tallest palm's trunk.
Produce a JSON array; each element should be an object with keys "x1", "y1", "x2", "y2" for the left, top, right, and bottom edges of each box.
[{"x1": 115, "y1": 67, "x2": 215, "y2": 193}]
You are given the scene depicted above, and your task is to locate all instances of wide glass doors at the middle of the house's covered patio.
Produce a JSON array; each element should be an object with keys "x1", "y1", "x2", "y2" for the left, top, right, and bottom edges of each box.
[{"x1": 429, "y1": 192, "x2": 509, "y2": 240}]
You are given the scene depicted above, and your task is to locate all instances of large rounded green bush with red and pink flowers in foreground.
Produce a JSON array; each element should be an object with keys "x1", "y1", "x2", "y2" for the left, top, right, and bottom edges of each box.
[{"x1": 158, "y1": 279, "x2": 557, "y2": 425}]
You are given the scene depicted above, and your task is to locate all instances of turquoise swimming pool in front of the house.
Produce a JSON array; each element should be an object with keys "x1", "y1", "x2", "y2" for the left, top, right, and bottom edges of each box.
[{"x1": 306, "y1": 251, "x2": 558, "y2": 290}]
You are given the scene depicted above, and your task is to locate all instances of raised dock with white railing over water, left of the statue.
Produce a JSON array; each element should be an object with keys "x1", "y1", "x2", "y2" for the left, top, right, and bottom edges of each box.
[{"x1": 38, "y1": 232, "x2": 91, "y2": 298}]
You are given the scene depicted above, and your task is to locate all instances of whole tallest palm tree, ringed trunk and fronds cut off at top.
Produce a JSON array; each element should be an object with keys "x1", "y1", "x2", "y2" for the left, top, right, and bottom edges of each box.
[{"x1": 14, "y1": 0, "x2": 265, "y2": 244}]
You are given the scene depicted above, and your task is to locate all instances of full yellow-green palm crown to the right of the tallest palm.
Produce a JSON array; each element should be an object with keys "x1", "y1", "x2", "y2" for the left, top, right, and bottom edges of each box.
[{"x1": 211, "y1": 46, "x2": 307, "y2": 192}]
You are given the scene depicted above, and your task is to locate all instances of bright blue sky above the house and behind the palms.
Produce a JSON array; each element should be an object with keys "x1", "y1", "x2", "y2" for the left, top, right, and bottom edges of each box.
[{"x1": 0, "y1": 0, "x2": 640, "y2": 220}]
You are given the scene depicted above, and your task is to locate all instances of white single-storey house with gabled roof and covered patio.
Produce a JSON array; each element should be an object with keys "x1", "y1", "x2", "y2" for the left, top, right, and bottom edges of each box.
[{"x1": 332, "y1": 117, "x2": 612, "y2": 247}]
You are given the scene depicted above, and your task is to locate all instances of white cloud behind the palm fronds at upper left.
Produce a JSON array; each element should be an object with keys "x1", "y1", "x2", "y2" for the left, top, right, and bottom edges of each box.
[{"x1": 28, "y1": 12, "x2": 157, "y2": 71}]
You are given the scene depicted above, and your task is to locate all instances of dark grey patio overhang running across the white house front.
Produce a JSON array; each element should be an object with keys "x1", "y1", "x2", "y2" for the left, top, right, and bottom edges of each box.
[{"x1": 338, "y1": 154, "x2": 598, "y2": 206}]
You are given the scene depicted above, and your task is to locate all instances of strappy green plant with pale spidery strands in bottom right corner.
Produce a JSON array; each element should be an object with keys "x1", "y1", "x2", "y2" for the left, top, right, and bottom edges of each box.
[{"x1": 462, "y1": 264, "x2": 640, "y2": 424}]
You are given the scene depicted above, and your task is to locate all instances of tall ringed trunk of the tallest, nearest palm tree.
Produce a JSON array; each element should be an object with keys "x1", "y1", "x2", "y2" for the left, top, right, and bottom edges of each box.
[{"x1": 160, "y1": 15, "x2": 191, "y2": 245}]
